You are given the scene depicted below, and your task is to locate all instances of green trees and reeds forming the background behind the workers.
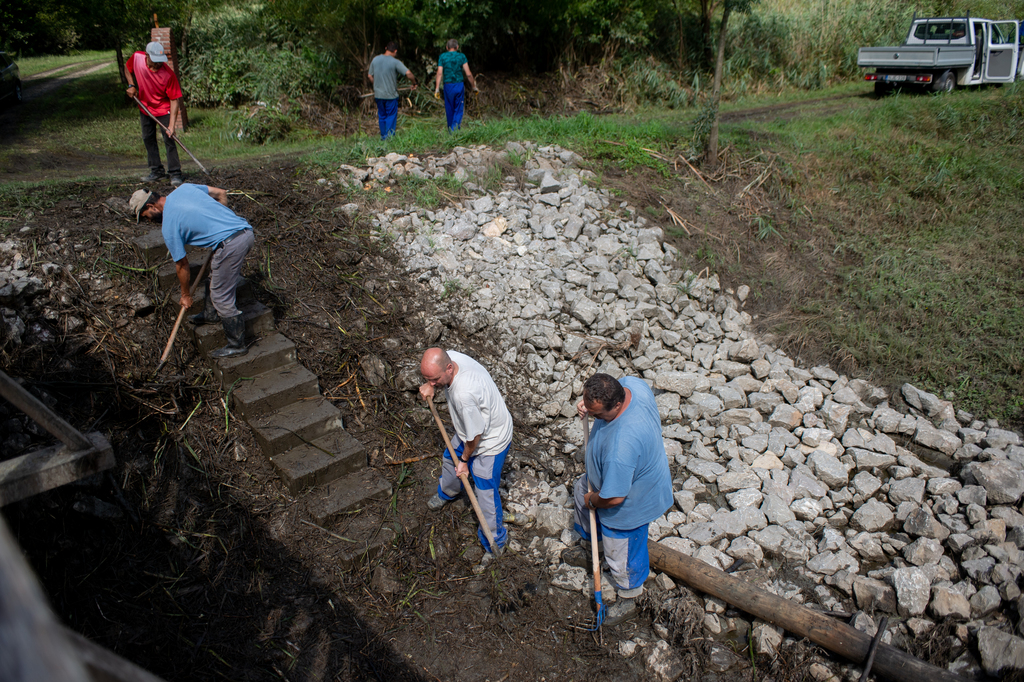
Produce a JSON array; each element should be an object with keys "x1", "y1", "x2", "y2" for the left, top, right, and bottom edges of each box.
[{"x1": 6, "y1": 0, "x2": 1024, "y2": 108}]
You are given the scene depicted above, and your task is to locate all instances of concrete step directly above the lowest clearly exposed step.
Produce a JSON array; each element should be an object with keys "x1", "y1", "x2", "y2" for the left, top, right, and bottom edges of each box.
[{"x1": 270, "y1": 429, "x2": 367, "y2": 495}]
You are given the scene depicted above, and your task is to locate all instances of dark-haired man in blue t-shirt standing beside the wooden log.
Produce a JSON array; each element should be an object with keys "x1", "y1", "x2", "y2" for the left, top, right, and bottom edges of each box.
[{"x1": 563, "y1": 374, "x2": 672, "y2": 625}]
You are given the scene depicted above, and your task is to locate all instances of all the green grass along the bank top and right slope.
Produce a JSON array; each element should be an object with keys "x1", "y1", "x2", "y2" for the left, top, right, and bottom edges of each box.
[{"x1": 0, "y1": 63, "x2": 1024, "y2": 426}]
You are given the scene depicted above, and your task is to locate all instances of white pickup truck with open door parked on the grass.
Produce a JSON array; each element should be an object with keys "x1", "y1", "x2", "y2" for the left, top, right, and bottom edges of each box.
[{"x1": 857, "y1": 16, "x2": 1024, "y2": 95}]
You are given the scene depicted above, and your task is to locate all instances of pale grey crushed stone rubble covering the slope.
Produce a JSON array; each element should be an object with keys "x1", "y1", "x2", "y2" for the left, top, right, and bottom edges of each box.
[{"x1": 350, "y1": 141, "x2": 1024, "y2": 680}]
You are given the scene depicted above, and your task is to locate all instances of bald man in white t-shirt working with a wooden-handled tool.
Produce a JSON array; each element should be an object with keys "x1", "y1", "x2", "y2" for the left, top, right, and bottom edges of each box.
[{"x1": 420, "y1": 348, "x2": 512, "y2": 552}]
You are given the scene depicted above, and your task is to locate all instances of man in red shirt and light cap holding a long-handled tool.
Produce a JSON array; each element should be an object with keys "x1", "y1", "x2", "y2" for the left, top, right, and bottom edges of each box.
[{"x1": 125, "y1": 41, "x2": 182, "y2": 187}]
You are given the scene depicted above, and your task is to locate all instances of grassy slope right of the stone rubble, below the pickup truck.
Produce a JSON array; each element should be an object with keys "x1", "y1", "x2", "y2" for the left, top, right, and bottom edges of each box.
[{"x1": 716, "y1": 87, "x2": 1024, "y2": 427}]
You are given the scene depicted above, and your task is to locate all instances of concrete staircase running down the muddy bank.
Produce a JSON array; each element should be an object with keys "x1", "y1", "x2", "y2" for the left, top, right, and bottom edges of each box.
[{"x1": 134, "y1": 229, "x2": 399, "y2": 567}]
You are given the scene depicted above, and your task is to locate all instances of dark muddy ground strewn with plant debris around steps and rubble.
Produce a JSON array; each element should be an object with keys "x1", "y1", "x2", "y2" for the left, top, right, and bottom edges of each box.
[{"x1": 0, "y1": 66, "x2": 940, "y2": 681}]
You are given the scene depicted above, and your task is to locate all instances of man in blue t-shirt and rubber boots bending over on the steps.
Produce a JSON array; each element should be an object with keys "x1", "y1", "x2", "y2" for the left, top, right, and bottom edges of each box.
[{"x1": 128, "y1": 183, "x2": 255, "y2": 357}]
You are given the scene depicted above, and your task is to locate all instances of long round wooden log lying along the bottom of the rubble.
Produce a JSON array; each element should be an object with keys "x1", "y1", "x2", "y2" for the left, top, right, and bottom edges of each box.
[{"x1": 647, "y1": 541, "x2": 966, "y2": 682}]
